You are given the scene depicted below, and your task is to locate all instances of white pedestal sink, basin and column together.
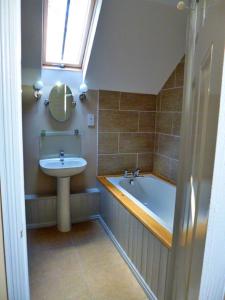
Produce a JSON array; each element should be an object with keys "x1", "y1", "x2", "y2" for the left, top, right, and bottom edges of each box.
[{"x1": 39, "y1": 157, "x2": 87, "y2": 232}]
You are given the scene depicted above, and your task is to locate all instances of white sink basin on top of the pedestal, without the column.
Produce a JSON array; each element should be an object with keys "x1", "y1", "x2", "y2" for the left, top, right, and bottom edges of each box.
[{"x1": 39, "y1": 157, "x2": 87, "y2": 177}]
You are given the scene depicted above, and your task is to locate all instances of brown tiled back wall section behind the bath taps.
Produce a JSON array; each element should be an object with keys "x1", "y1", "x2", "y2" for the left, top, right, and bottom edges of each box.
[{"x1": 98, "y1": 91, "x2": 156, "y2": 175}]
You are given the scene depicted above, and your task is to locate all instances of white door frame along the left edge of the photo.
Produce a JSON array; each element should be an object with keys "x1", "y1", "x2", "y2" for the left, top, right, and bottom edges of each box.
[{"x1": 0, "y1": 0, "x2": 30, "y2": 300}]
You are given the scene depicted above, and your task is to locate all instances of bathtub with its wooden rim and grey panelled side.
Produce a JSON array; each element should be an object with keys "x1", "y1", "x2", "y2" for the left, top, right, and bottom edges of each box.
[{"x1": 97, "y1": 174, "x2": 176, "y2": 300}]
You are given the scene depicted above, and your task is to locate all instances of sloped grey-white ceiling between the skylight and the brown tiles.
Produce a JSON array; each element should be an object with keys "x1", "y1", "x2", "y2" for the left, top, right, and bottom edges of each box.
[{"x1": 86, "y1": 0, "x2": 186, "y2": 94}]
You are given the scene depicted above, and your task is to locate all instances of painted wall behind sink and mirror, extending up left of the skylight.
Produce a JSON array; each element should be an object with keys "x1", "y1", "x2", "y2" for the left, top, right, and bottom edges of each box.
[{"x1": 21, "y1": 0, "x2": 98, "y2": 195}]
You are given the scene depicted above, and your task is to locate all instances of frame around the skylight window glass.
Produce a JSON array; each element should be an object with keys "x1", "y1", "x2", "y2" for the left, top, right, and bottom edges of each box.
[{"x1": 42, "y1": 0, "x2": 97, "y2": 71}]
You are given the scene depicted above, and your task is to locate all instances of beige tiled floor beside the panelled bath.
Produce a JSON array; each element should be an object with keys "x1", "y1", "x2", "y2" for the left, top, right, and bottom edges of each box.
[{"x1": 28, "y1": 221, "x2": 147, "y2": 300}]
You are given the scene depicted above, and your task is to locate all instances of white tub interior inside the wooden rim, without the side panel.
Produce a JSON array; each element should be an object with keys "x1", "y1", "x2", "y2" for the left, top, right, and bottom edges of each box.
[{"x1": 107, "y1": 175, "x2": 176, "y2": 233}]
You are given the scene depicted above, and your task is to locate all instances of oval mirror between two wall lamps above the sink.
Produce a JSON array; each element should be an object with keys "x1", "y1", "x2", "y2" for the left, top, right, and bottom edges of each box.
[{"x1": 49, "y1": 84, "x2": 73, "y2": 122}]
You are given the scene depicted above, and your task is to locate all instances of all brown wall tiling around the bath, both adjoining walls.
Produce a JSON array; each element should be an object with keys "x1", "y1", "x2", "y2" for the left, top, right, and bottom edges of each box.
[{"x1": 98, "y1": 60, "x2": 184, "y2": 181}]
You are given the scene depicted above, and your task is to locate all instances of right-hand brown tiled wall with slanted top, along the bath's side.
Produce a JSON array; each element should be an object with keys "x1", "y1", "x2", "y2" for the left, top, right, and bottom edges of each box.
[{"x1": 153, "y1": 60, "x2": 184, "y2": 181}]
